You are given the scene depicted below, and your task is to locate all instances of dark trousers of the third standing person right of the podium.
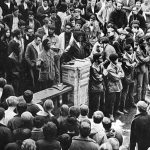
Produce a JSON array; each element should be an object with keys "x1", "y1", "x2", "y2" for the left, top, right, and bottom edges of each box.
[{"x1": 121, "y1": 79, "x2": 134, "y2": 109}]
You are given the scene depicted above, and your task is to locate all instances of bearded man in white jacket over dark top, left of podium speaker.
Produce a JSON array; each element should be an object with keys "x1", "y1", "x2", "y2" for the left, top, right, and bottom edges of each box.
[{"x1": 59, "y1": 23, "x2": 74, "y2": 54}]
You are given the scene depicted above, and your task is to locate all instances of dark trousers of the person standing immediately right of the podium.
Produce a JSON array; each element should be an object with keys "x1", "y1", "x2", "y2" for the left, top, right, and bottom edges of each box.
[{"x1": 89, "y1": 92, "x2": 104, "y2": 118}]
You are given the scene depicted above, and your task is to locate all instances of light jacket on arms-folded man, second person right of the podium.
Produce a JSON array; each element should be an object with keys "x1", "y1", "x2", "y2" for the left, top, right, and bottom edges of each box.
[{"x1": 107, "y1": 63, "x2": 124, "y2": 93}]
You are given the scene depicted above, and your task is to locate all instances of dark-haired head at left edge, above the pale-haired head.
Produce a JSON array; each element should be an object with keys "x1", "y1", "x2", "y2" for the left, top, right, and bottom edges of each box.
[{"x1": 1, "y1": 84, "x2": 15, "y2": 100}]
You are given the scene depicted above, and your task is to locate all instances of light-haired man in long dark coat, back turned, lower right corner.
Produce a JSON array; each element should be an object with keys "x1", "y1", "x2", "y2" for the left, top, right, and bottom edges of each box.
[{"x1": 130, "y1": 101, "x2": 150, "y2": 150}]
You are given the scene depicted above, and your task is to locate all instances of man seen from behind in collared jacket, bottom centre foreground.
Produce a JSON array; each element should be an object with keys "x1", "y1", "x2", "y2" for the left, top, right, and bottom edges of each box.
[{"x1": 69, "y1": 119, "x2": 99, "y2": 150}]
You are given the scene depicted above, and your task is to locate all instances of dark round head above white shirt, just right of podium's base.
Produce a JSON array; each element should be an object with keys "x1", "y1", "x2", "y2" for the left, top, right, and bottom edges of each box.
[{"x1": 93, "y1": 111, "x2": 104, "y2": 124}]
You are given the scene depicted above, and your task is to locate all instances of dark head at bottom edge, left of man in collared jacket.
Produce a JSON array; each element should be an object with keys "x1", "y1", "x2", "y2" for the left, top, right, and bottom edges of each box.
[{"x1": 58, "y1": 133, "x2": 72, "y2": 150}]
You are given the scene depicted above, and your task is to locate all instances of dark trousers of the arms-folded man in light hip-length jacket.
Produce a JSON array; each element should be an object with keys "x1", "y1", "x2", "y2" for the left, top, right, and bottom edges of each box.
[{"x1": 105, "y1": 92, "x2": 121, "y2": 115}]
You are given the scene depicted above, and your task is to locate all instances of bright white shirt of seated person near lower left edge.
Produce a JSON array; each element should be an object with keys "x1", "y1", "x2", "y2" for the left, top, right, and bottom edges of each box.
[{"x1": 5, "y1": 107, "x2": 17, "y2": 125}]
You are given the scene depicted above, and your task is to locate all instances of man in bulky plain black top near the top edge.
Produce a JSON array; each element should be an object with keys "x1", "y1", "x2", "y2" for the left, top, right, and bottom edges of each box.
[{"x1": 108, "y1": 2, "x2": 128, "y2": 29}]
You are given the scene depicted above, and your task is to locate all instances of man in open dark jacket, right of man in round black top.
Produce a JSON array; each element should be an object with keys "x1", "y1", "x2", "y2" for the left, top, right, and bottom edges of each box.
[{"x1": 129, "y1": 7, "x2": 146, "y2": 31}]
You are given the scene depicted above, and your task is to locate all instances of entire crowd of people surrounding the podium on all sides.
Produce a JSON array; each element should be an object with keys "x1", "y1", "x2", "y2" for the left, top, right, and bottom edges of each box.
[{"x1": 0, "y1": 0, "x2": 150, "y2": 150}]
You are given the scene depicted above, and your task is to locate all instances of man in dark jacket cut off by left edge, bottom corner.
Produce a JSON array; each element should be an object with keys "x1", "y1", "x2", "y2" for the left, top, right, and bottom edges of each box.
[{"x1": 0, "y1": 107, "x2": 12, "y2": 150}]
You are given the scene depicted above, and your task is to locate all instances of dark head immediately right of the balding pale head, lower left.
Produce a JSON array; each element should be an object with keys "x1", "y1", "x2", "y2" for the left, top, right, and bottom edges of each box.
[{"x1": 33, "y1": 116, "x2": 45, "y2": 128}]
